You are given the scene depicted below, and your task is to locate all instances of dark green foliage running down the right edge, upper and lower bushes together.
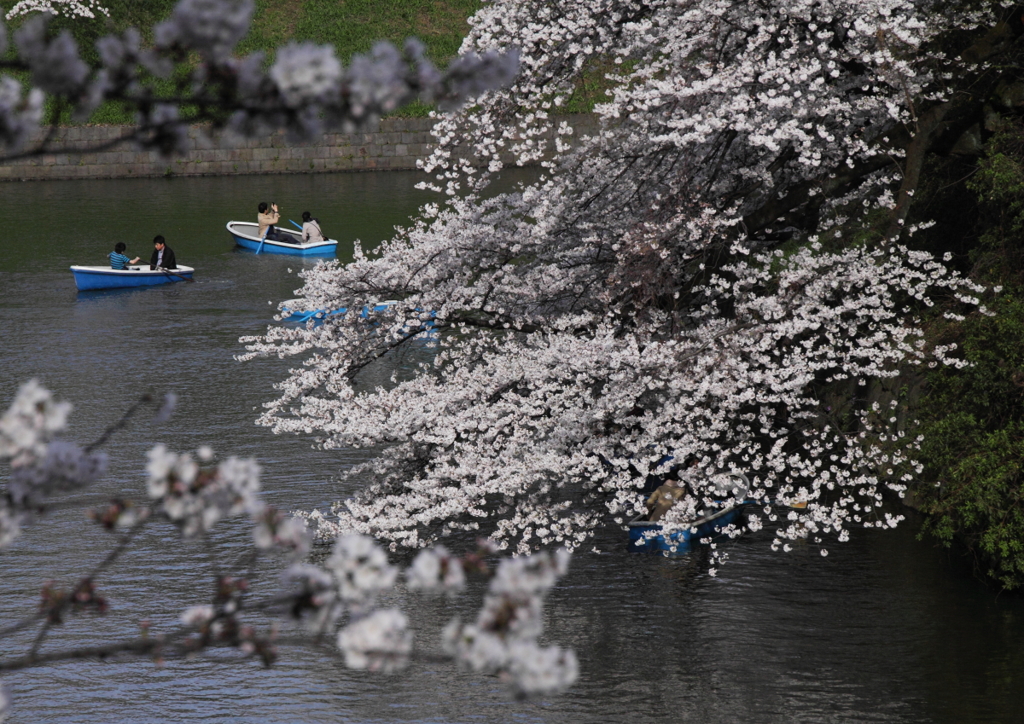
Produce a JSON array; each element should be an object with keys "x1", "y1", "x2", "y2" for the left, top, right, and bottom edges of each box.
[{"x1": 914, "y1": 127, "x2": 1024, "y2": 589}]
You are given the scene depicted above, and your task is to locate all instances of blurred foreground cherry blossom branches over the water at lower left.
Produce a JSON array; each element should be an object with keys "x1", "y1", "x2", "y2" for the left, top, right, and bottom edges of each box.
[{"x1": 0, "y1": 380, "x2": 578, "y2": 721}]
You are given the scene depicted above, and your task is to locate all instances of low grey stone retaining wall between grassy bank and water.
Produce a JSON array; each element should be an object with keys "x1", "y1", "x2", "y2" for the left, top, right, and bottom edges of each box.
[{"x1": 0, "y1": 116, "x2": 595, "y2": 181}]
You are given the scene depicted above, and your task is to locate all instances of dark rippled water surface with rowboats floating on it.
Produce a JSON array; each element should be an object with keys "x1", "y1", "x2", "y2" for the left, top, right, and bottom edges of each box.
[{"x1": 0, "y1": 172, "x2": 1024, "y2": 724}]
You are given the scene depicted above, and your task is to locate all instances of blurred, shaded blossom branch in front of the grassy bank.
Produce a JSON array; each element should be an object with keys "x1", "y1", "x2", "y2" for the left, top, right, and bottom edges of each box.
[{"x1": 0, "y1": 0, "x2": 518, "y2": 155}]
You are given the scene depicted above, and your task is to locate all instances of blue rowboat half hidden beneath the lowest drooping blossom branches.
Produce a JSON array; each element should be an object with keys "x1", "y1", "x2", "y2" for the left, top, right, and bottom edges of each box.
[{"x1": 628, "y1": 473, "x2": 751, "y2": 556}]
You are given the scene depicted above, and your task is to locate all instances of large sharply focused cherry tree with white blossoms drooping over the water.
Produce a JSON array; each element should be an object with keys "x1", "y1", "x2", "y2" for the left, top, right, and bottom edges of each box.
[{"x1": 240, "y1": 0, "x2": 1022, "y2": 555}]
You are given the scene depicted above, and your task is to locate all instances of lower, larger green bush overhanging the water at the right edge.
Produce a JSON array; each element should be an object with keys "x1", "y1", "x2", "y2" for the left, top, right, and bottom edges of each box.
[{"x1": 916, "y1": 297, "x2": 1024, "y2": 589}]
